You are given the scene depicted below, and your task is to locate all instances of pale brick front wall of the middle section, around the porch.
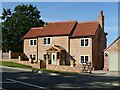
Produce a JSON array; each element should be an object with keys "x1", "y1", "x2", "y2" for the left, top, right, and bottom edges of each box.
[{"x1": 38, "y1": 36, "x2": 69, "y2": 64}]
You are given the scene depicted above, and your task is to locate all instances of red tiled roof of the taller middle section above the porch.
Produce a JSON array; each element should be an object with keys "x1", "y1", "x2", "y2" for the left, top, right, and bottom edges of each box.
[{"x1": 39, "y1": 20, "x2": 77, "y2": 36}]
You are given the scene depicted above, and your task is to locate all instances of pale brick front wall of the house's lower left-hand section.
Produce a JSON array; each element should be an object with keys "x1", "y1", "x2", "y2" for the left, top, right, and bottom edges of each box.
[{"x1": 23, "y1": 38, "x2": 37, "y2": 59}]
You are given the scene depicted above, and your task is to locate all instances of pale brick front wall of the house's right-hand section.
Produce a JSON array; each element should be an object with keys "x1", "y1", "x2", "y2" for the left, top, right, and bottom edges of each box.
[{"x1": 70, "y1": 38, "x2": 92, "y2": 66}]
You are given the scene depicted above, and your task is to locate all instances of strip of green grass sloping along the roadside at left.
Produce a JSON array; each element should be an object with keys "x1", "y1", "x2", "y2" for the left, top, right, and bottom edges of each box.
[{"x1": 0, "y1": 61, "x2": 32, "y2": 69}]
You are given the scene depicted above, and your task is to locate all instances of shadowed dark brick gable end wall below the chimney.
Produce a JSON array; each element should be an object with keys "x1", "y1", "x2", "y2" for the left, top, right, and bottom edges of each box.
[{"x1": 92, "y1": 26, "x2": 106, "y2": 69}]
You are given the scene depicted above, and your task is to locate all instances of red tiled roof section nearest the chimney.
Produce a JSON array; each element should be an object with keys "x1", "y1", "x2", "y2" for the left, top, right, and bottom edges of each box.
[{"x1": 72, "y1": 21, "x2": 99, "y2": 37}]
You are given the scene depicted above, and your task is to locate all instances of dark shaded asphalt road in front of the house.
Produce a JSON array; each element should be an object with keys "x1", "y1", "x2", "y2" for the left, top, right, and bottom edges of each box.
[{"x1": 0, "y1": 67, "x2": 120, "y2": 90}]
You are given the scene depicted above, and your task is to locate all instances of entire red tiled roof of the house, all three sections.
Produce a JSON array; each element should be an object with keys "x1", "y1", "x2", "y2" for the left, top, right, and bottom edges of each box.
[{"x1": 24, "y1": 20, "x2": 99, "y2": 38}]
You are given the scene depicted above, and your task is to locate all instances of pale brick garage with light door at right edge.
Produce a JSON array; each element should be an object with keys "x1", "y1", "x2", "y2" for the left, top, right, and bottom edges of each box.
[{"x1": 104, "y1": 36, "x2": 120, "y2": 71}]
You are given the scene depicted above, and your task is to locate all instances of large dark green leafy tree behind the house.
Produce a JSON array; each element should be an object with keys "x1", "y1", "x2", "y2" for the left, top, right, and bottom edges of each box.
[{"x1": 1, "y1": 4, "x2": 44, "y2": 52}]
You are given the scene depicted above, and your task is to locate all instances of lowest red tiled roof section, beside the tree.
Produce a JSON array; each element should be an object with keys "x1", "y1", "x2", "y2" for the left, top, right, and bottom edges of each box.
[{"x1": 23, "y1": 27, "x2": 43, "y2": 38}]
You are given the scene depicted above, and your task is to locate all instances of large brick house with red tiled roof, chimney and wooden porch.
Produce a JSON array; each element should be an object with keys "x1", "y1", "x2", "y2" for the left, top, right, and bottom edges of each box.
[{"x1": 24, "y1": 11, "x2": 106, "y2": 71}]
